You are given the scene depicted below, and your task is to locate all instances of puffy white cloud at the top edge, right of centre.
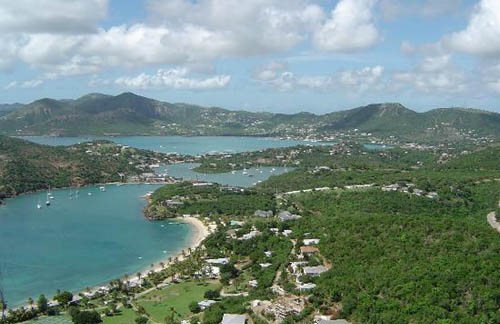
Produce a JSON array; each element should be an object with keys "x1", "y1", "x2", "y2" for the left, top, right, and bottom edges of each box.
[{"x1": 313, "y1": 0, "x2": 380, "y2": 52}]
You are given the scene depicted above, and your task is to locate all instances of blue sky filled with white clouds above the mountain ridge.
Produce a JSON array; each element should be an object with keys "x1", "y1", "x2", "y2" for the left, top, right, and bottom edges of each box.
[{"x1": 0, "y1": 0, "x2": 500, "y2": 113}]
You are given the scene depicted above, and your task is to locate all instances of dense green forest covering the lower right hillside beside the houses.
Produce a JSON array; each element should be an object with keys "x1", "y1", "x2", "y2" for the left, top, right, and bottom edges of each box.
[{"x1": 286, "y1": 183, "x2": 500, "y2": 323}]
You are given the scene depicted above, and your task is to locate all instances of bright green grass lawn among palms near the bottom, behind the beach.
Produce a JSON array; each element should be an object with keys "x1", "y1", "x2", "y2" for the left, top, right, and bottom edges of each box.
[{"x1": 137, "y1": 281, "x2": 219, "y2": 322}]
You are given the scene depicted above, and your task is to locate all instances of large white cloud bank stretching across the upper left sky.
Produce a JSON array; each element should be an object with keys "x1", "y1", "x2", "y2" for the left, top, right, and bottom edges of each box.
[{"x1": 0, "y1": 0, "x2": 324, "y2": 78}]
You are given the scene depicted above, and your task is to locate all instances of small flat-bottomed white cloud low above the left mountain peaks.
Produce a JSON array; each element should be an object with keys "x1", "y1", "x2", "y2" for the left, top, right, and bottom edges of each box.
[{"x1": 115, "y1": 68, "x2": 231, "y2": 90}]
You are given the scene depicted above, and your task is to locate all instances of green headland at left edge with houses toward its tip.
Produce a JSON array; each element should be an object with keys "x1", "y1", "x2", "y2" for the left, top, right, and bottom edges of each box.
[{"x1": 0, "y1": 135, "x2": 170, "y2": 200}]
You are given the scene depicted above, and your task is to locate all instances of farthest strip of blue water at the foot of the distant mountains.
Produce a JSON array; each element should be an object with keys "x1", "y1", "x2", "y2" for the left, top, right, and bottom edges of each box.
[{"x1": 21, "y1": 136, "x2": 322, "y2": 155}]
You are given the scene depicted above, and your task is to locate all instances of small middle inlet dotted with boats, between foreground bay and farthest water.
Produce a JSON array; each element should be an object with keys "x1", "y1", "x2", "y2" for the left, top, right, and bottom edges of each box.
[{"x1": 162, "y1": 163, "x2": 293, "y2": 187}]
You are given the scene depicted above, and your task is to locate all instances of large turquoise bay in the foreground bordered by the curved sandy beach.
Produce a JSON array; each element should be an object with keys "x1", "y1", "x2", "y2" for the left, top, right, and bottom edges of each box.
[{"x1": 0, "y1": 185, "x2": 191, "y2": 307}]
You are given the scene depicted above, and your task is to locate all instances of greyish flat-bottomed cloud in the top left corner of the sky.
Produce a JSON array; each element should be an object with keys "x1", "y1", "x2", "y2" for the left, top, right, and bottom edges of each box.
[{"x1": 0, "y1": 0, "x2": 108, "y2": 34}]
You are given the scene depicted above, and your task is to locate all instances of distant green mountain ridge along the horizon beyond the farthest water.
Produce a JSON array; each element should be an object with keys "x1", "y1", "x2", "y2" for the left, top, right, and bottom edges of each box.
[{"x1": 0, "y1": 92, "x2": 500, "y2": 140}]
